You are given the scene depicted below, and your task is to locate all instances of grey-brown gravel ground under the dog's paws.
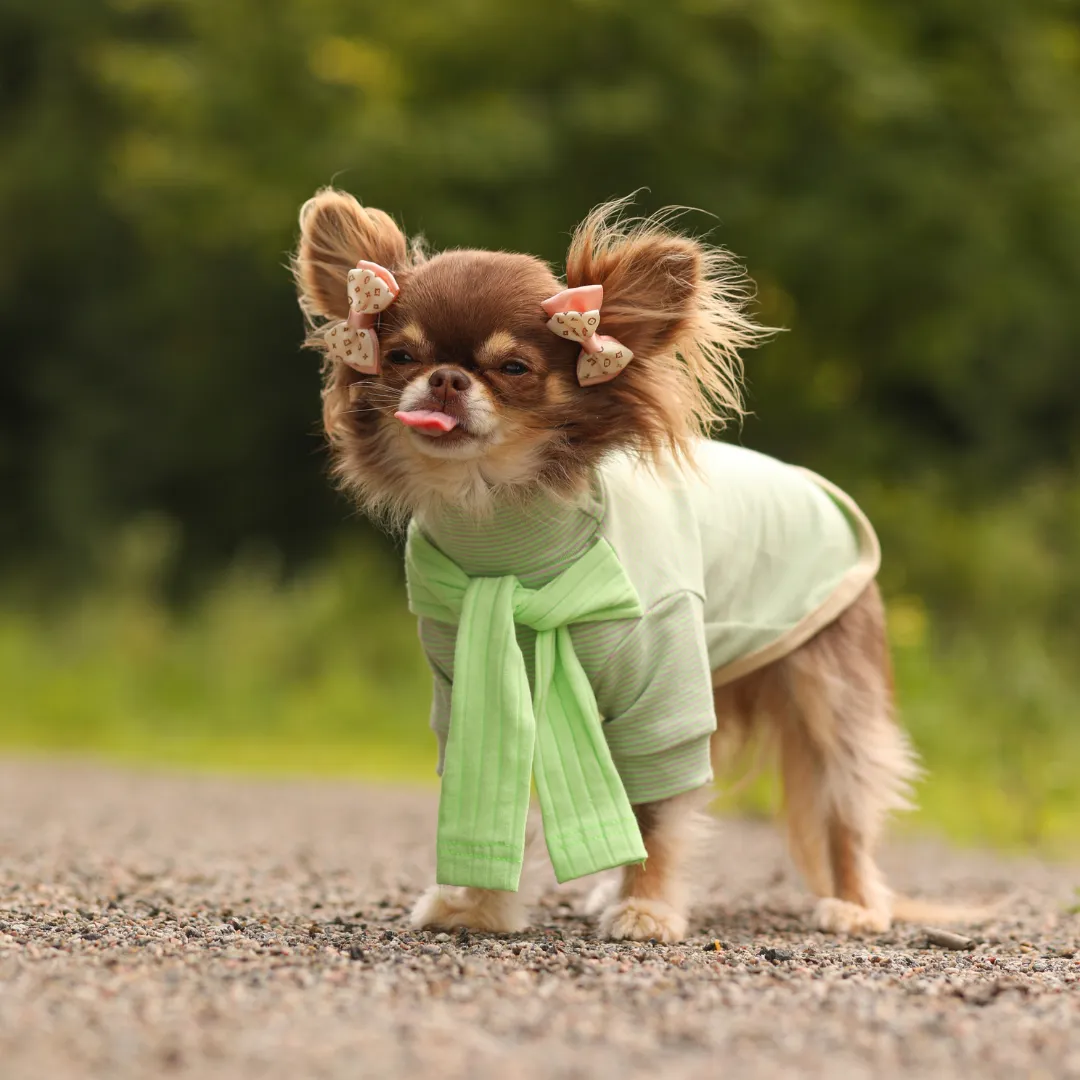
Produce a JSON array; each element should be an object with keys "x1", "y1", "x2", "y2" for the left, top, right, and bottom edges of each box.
[{"x1": 0, "y1": 760, "x2": 1080, "y2": 1080}]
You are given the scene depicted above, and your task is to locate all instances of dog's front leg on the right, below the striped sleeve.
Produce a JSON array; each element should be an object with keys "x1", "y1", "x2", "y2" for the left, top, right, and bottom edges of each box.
[{"x1": 599, "y1": 791, "x2": 705, "y2": 942}]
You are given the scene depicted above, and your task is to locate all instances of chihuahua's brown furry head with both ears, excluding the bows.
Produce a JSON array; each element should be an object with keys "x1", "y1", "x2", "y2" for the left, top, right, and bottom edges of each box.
[{"x1": 294, "y1": 189, "x2": 760, "y2": 519}]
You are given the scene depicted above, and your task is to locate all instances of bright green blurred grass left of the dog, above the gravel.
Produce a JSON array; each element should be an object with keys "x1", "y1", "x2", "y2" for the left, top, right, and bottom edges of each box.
[{"x1": 0, "y1": 519, "x2": 434, "y2": 780}]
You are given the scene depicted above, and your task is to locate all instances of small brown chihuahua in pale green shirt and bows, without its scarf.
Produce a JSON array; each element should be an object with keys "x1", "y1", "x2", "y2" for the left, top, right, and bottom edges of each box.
[{"x1": 293, "y1": 189, "x2": 919, "y2": 942}]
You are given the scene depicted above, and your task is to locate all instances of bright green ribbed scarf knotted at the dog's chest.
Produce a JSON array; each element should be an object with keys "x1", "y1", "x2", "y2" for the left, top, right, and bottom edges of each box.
[{"x1": 405, "y1": 523, "x2": 645, "y2": 891}]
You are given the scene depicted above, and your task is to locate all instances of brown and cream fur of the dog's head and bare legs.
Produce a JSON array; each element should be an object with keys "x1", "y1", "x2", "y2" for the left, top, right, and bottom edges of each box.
[{"x1": 294, "y1": 189, "x2": 917, "y2": 941}]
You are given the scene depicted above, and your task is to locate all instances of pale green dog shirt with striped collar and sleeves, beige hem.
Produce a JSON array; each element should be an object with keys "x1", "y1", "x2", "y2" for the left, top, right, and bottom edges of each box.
[{"x1": 417, "y1": 440, "x2": 879, "y2": 802}]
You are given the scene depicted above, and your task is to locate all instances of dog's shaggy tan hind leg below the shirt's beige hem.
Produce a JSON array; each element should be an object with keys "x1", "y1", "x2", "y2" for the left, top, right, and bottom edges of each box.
[{"x1": 770, "y1": 585, "x2": 918, "y2": 933}]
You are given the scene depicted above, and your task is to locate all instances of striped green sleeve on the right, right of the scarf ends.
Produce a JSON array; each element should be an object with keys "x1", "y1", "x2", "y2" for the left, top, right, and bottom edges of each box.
[{"x1": 595, "y1": 592, "x2": 716, "y2": 802}]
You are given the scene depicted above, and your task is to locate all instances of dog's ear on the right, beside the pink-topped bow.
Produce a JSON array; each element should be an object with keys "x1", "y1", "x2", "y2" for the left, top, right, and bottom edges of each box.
[{"x1": 566, "y1": 206, "x2": 705, "y2": 362}]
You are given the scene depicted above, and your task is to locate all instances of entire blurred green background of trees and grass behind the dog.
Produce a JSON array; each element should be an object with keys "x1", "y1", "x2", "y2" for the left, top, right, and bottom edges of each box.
[{"x1": 0, "y1": 0, "x2": 1080, "y2": 849}]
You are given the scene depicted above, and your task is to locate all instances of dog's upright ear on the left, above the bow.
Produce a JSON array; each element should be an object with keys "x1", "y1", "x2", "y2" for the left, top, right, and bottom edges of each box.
[{"x1": 293, "y1": 188, "x2": 408, "y2": 321}]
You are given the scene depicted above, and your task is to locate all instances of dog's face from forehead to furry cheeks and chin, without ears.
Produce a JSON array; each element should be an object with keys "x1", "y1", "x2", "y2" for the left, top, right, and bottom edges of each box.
[{"x1": 325, "y1": 252, "x2": 609, "y2": 518}]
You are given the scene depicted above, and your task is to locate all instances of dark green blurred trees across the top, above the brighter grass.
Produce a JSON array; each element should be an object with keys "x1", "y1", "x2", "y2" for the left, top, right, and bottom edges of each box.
[{"x1": 0, "y1": 0, "x2": 1080, "y2": 596}]
